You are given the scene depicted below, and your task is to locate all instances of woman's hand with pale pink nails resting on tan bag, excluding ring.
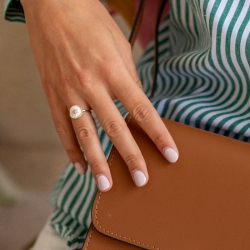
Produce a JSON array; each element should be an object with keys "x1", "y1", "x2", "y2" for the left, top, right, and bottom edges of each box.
[{"x1": 22, "y1": 0, "x2": 178, "y2": 191}]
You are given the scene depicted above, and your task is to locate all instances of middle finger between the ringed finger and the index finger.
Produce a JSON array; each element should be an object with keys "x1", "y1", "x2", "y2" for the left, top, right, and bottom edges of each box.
[{"x1": 87, "y1": 89, "x2": 148, "y2": 187}]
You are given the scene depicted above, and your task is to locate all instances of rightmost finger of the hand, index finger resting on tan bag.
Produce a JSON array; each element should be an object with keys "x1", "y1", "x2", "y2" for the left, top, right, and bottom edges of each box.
[{"x1": 114, "y1": 74, "x2": 179, "y2": 163}]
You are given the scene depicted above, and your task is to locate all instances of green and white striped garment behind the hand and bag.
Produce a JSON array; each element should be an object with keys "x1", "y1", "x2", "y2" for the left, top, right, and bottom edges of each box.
[{"x1": 5, "y1": 0, "x2": 250, "y2": 250}]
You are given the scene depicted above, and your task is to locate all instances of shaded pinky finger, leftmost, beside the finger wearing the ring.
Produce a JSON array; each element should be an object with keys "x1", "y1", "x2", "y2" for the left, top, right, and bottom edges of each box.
[{"x1": 50, "y1": 97, "x2": 88, "y2": 174}]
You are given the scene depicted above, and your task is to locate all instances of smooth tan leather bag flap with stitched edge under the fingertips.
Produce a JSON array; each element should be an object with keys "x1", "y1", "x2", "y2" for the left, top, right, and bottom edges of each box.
[{"x1": 83, "y1": 116, "x2": 250, "y2": 250}]
